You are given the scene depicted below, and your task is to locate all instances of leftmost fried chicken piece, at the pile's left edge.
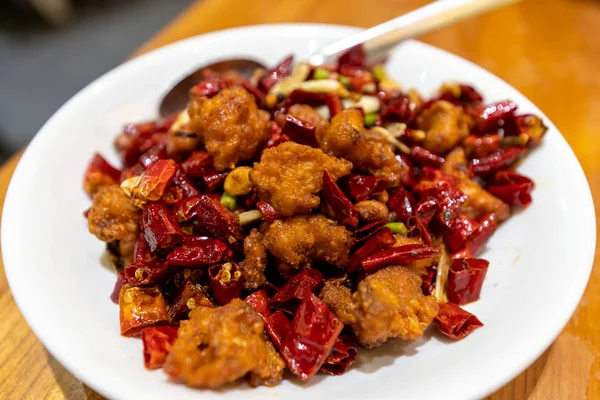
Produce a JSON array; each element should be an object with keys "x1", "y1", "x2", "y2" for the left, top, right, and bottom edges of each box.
[{"x1": 88, "y1": 185, "x2": 140, "y2": 242}]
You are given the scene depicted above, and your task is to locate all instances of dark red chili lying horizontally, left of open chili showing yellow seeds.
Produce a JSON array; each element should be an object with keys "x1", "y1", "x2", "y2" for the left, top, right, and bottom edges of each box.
[{"x1": 167, "y1": 236, "x2": 233, "y2": 268}]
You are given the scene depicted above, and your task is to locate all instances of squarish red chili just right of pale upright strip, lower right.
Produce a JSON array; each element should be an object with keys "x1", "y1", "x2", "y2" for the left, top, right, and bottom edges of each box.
[{"x1": 446, "y1": 258, "x2": 490, "y2": 305}]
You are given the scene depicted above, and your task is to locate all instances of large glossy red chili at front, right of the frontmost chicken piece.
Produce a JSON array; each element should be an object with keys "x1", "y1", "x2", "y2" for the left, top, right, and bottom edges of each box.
[{"x1": 281, "y1": 294, "x2": 344, "y2": 381}]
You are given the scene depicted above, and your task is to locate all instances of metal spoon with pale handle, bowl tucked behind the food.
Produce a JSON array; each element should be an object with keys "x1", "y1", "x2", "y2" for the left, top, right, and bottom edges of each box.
[{"x1": 159, "y1": 0, "x2": 521, "y2": 117}]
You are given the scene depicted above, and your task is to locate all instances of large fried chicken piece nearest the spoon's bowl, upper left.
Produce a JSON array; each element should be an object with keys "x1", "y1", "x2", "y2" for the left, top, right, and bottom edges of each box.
[{"x1": 190, "y1": 86, "x2": 270, "y2": 171}]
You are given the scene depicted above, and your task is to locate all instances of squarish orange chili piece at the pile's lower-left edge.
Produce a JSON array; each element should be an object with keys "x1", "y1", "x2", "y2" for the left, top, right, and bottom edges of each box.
[{"x1": 119, "y1": 284, "x2": 169, "y2": 336}]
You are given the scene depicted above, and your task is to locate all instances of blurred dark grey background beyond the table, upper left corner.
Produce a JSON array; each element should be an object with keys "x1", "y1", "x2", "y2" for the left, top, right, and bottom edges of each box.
[{"x1": 0, "y1": 0, "x2": 194, "y2": 162}]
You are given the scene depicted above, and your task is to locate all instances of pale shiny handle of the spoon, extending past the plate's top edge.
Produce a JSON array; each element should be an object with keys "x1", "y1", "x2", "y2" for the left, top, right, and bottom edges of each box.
[{"x1": 309, "y1": 0, "x2": 521, "y2": 65}]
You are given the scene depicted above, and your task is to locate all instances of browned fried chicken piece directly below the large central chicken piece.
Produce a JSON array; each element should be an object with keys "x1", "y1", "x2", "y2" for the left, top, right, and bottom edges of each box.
[{"x1": 264, "y1": 216, "x2": 352, "y2": 269}]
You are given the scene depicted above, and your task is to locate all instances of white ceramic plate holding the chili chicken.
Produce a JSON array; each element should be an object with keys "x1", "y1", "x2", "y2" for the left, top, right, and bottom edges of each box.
[{"x1": 2, "y1": 25, "x2": 596, "y2": 400}]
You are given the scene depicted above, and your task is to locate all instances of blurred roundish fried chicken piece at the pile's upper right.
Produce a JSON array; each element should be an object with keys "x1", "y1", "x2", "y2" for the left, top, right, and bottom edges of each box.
[{"x1": 415, "y1": 100, "x2": 473, "y2": 155}]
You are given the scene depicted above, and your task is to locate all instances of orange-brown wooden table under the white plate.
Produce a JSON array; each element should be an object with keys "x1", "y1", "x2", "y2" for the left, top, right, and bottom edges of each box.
[{"x1": 0, "y1": 0, "x2": 600, "y2": 400}]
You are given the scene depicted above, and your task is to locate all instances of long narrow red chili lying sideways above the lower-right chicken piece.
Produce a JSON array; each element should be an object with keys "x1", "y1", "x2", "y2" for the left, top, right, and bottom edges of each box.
[{"x1": 360, "y1": 244, "x2": 439, "y2": 274}]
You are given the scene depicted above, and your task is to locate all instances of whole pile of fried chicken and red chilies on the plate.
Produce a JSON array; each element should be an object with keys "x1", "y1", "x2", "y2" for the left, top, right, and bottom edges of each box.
[{"x1": 84, "y1": 47, "x2": 546, "y2": 388}]
